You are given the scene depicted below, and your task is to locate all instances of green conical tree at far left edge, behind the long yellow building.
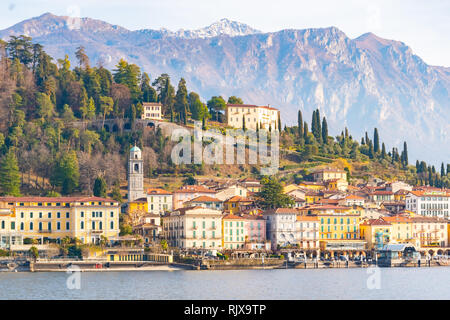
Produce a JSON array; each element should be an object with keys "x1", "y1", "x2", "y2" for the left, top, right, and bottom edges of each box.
[{"x1": 0, "y1": 150, "x2": 20, "y2": 197}]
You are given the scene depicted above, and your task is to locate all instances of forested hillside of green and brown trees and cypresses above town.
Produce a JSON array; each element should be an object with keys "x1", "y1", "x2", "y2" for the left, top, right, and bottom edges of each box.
[{"x1": 0, "y1": 36, "x2": 449, "y2": 199}]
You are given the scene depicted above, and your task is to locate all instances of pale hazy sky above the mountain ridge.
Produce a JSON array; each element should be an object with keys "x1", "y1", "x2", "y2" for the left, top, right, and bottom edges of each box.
[{"x1": 0, "y1": 0, "x2": 450, "y2": 67}]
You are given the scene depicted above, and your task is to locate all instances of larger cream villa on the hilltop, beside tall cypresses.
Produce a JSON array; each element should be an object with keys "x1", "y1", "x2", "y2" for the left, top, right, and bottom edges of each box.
[{"x1": 226, "y1": 104, "x2": 280, "y2": 130}]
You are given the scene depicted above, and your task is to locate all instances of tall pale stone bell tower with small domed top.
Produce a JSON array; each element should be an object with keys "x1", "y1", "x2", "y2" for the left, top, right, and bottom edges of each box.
[{"x1": 128, "y1": 145, "x2": 145, "y2": 201}]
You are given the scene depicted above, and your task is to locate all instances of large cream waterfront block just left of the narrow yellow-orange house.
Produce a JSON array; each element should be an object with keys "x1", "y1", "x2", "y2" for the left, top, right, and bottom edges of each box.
[{"x1": 162, "y1": 207, "x2": 222, "y2": 249}]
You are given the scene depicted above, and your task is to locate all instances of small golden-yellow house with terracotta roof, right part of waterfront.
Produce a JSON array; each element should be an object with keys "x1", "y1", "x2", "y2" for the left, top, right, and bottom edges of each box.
[{"x1": 359, "y1": 218, "x2": 392, "y2": 250}]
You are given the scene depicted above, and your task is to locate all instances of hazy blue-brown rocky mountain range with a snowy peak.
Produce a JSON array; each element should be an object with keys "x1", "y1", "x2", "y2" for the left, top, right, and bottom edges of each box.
[{"x1": 0, "y1": 13, "x2": 450, "y2": 165}]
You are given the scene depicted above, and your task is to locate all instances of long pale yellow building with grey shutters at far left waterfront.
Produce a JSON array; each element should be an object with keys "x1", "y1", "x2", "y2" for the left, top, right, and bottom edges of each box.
[{"x1": 0, "y1": 196, "x2": 120, "y2": 243}]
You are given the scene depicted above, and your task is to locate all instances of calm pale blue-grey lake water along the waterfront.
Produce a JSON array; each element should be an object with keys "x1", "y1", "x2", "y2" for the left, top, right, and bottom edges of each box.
[{"x1": 0, "y1": 267, "x2": 450, "y2": 300}]
